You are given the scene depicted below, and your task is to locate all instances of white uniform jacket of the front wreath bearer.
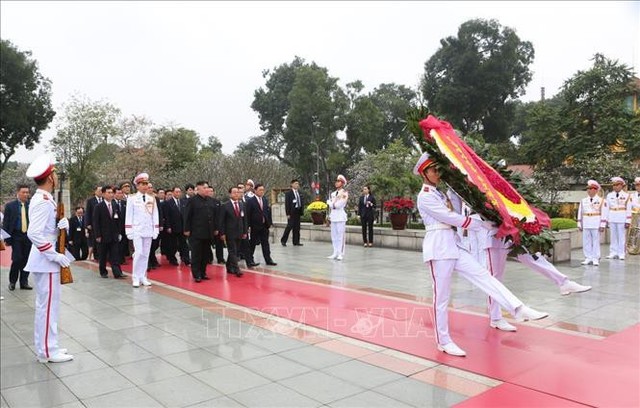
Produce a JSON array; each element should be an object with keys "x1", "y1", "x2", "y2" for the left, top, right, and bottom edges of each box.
[{"x1": 418, "y1": 184, "x2": 483, "y2": 262}]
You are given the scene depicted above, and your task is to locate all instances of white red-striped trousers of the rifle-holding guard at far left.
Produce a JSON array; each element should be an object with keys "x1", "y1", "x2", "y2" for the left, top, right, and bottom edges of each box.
[{"x1": 31, "y1": 272, "x2": 60, "y2": 358}]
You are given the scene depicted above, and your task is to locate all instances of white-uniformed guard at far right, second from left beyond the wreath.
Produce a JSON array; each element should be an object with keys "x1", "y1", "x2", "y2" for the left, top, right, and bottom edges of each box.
[{"x1": 605, "y1": 177, "x2": 631, "y2": 260}]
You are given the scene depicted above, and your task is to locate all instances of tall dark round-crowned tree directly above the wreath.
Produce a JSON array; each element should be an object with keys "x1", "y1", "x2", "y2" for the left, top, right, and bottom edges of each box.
[{"x1": 422, "y1": 19, "x2": 534, "y2": 143}]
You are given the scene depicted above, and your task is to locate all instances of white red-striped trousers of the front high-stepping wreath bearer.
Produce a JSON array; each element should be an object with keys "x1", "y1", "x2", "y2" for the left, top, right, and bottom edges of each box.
[{"x1": 429, "y1": 251, "x2": 523, "y2": 345}]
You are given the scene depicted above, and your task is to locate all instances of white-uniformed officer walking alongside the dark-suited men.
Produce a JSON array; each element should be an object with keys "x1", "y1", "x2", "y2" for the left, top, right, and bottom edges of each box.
[{"x1": 124, "y1": 173, "x2": 160, "y2": 288}]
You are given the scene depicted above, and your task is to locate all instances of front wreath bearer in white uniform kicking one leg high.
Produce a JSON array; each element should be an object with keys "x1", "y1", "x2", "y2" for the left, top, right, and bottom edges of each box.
[{"x1": 413, "y1": 153, "x2": 548, "y2": 357}]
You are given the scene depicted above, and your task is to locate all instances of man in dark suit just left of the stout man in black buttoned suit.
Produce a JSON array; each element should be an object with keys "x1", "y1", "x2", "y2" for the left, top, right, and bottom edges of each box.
[{"x1": 164, "y1": 186, "x2": 191, "y2": 266}]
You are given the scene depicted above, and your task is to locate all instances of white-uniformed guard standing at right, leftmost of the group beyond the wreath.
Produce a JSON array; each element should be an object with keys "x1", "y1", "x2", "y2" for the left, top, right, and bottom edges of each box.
[{"x1": 578, "y1": 180, "x2": 607, "y2": 266}]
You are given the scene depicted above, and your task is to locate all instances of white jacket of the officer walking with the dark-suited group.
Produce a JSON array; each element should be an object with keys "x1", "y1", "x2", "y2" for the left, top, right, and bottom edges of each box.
[{"x1": 124, "y1": 192, "x2": 160, "y2": 240}]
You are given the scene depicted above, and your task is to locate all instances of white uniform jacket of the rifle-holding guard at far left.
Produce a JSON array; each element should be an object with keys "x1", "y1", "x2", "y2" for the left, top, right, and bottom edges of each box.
[{"x1": 24, "y1": 189, "x2": 60, "y2": 273}]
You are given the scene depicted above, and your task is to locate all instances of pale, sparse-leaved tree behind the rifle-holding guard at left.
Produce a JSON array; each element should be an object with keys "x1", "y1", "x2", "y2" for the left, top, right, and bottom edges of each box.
[{"x1": 51, "y1": 95, "x2": 121, "y2": 203}]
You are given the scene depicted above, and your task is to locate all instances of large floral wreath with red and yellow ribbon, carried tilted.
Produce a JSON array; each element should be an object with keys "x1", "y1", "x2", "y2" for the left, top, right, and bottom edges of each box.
[{"x1": 408, "y1": 109, "x2": 556, "y2": 256}]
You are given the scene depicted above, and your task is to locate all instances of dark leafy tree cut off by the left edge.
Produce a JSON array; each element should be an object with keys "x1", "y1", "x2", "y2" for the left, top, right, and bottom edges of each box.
[{"x1": 0, "y1": 40, "x2": 56, "y2": 175}]
